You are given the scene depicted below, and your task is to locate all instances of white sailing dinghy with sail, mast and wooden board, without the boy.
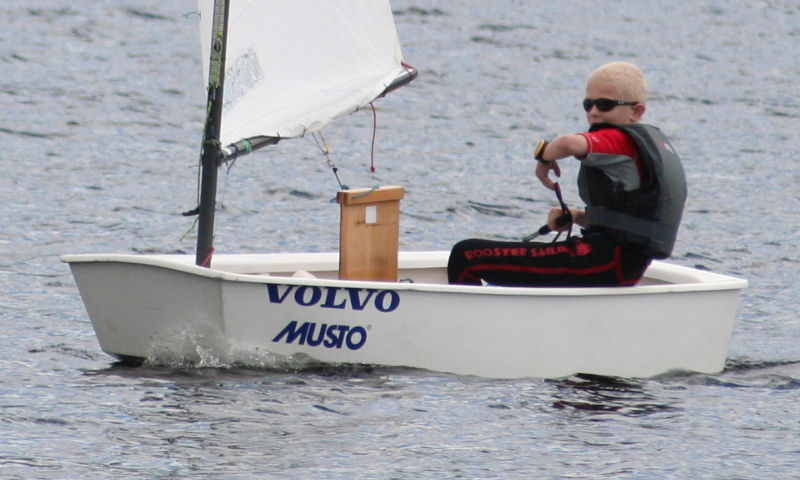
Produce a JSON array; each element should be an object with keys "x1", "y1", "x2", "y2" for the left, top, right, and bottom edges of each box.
[{"x1": 62, "y1": 0, "x2": 747, "y2": 378}]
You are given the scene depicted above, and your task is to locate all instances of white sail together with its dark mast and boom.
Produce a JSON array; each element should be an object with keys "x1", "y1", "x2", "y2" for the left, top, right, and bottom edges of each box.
[{"x1": 191, "y1": 0, "x2": 416, "y2": 267}]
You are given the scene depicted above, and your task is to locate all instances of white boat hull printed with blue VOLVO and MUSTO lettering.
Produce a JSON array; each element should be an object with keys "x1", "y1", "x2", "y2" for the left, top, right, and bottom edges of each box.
[{"x1": 63, "y1": 252, "x2": 747, "y2": 378}]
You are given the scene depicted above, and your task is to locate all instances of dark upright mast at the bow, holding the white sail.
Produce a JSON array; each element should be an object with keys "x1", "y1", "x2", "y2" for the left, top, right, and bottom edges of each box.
[{"x1": 195, "y1": 0, "x2": 229, "y2": 267}]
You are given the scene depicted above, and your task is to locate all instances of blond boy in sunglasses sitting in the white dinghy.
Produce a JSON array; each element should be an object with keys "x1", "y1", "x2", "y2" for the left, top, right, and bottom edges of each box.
[{"x1": 447, "y1": 62, "x2": 686, "y2": 286}]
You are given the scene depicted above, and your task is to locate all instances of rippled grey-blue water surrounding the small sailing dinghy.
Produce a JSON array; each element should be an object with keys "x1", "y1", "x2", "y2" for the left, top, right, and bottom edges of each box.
[{"x1": 0, "y1": 0, "x2": 800, "y2": 479}]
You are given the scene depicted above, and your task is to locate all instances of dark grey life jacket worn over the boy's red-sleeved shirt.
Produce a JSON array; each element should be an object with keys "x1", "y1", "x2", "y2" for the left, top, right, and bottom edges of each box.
[{"x1": 578, "y1": 123, "x2": 686, "y2": 258}]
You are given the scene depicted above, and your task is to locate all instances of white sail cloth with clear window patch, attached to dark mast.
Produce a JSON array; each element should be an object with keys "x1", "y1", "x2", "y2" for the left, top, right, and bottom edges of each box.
[{"x1": 198, "y1": 0, "x2": 407, "y2": 145}]
